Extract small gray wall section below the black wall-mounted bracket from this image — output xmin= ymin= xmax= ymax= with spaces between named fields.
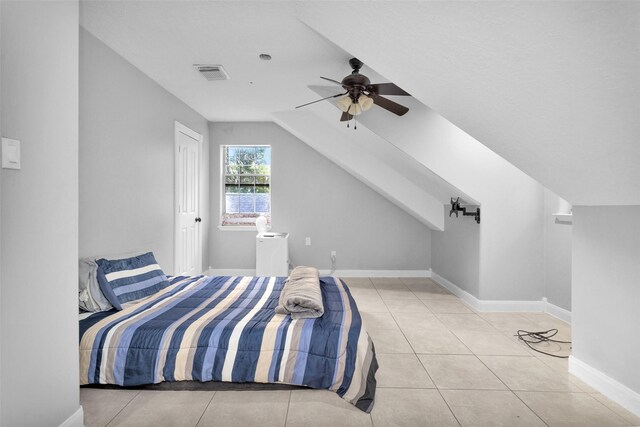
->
xmin=431 ymin=206 xmax=480 ymax=296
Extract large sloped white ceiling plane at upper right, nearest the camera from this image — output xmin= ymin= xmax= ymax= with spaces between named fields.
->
xmin=297 ymin=1 xmax=640 ymax=205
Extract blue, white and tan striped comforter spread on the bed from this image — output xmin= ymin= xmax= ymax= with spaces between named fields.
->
xmin=80 ymin=276 xmax=378 ymax=412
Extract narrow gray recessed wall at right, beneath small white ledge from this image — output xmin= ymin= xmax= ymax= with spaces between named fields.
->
xmin=544 ymin=188 xmax=572 ymax=311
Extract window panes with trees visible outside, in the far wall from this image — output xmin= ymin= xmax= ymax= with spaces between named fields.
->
xmin=222 ymin=145 xmax=271 ymax=226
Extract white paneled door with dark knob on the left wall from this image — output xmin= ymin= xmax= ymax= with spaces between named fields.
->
xmin=174 ymin=122 xmax=202 ymax=276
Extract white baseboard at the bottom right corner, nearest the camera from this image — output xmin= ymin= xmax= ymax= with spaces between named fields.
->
xmin=569 ymin=356 xmax=640 ymax=417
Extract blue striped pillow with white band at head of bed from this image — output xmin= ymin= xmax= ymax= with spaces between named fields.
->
xmin=96 ymin=252 xmax=169 ymax=310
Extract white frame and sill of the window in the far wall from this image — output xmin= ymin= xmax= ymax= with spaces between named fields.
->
xmin=218 ymin=144 xmax=273 ymax=230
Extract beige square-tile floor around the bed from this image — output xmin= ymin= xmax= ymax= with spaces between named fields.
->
xmin=80 ymin=278 xmax=640 ymax=427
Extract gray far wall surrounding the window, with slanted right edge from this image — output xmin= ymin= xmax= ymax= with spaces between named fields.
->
xmin=209 ymin=122 xmax=431 ymax=270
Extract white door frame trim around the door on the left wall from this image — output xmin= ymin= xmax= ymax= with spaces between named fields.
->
xmin=173 ymin=120 xmax=204 ymax=274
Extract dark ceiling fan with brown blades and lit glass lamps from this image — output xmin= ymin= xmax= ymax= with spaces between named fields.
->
xmin=296 ymin=58 xmax=410 ymax=122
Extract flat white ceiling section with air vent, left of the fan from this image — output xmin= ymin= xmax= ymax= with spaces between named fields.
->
xmin=81 ymin=1 xmax=351 ymax=121
